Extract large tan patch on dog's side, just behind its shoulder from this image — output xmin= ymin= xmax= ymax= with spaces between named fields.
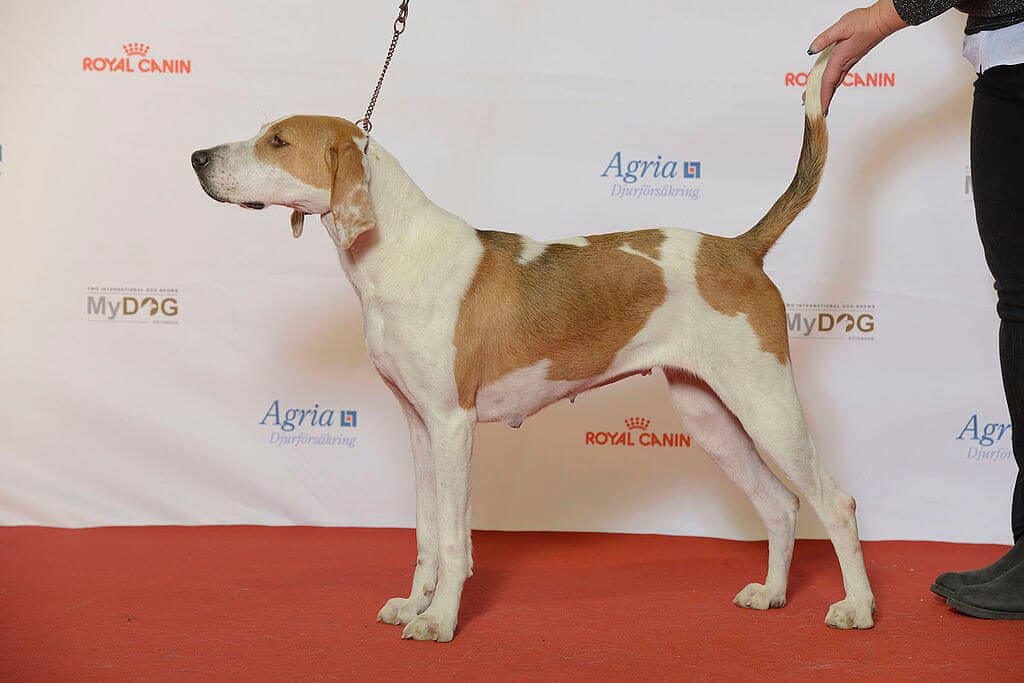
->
xmin=455 ymin=229 xmax=667 ymax=408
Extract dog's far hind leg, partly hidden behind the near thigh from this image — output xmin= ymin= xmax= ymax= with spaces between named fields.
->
xmin=665 ymin=369 xmax=800 ymax=609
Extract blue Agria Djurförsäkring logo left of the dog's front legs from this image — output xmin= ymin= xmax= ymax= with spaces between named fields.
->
xmin=259 ymin=398 xmax=359 ymax=449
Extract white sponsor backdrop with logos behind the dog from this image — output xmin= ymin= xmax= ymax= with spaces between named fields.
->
xmin=0 ymin=0 xmax=1015 ymax=542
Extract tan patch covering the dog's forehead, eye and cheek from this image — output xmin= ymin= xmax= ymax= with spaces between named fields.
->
xmin=253 ymin=116 xmax=364 ymax=189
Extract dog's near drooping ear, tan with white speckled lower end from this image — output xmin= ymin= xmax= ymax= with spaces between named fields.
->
xmin=328 ymin=139 xmax=377 ymax=247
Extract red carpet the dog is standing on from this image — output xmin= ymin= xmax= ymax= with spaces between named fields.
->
xmin=0 ymin=526 xmax=1024 ymax=681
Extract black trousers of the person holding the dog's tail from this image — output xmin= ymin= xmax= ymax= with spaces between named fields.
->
xmin=971 ymin=65 xmax=1024 ymax=542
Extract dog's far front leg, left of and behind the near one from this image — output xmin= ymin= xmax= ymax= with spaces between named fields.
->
xmin=377 ymin=397 xmax=437 ymax=624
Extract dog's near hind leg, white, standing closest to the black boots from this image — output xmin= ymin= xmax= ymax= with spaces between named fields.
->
xmin=710 ymin=362 xmax=874 ymax=629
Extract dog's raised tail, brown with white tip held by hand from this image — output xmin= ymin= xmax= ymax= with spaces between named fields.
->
xmin=736 ymin=47 xmax=831 ymax=258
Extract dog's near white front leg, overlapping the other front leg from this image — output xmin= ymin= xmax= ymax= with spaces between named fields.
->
xmin=401 ymin=410 xmax=476 ymax=642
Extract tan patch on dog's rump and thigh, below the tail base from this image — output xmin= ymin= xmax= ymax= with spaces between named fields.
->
xmin=696 ymin=234 xmax=790 ymax=366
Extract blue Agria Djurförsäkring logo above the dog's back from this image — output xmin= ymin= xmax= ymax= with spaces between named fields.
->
xmin=601 ymin=152 xmax=700 ymax=200
